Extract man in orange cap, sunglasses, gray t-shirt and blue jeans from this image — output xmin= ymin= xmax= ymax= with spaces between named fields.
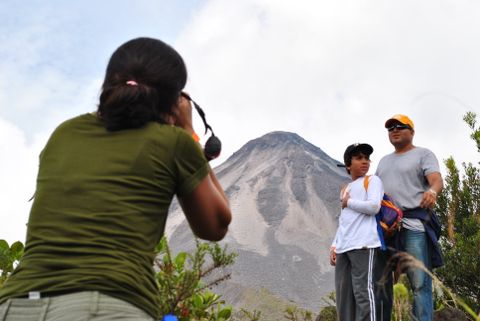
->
xmin=376 ymin=114 xmax=443 ymax=321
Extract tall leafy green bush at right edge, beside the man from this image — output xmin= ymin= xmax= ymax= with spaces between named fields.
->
xmin=436 ymin=112 xmax=480 ymax=311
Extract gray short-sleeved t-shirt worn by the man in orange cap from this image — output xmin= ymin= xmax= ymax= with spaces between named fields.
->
xmin=376 ymin=147 xmax=440 ymax=230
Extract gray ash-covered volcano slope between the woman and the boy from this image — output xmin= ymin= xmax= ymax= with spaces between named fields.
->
xmin=166 ymin=132 xmax=348 ymax=311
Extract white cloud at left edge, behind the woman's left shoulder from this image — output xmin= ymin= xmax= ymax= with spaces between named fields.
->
xmin=0 ymin=66 xmax=101 ymax=242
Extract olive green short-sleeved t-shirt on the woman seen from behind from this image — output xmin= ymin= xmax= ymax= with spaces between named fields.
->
xmin=0 ymin=114 xmax=209 ymax=318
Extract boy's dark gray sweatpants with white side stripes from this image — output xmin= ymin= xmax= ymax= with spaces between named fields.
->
xmin=335 ymin=248 xmax=390 ymax=321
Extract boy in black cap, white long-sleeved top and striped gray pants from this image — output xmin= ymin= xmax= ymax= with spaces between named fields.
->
xmin=330 ymin=144 xmax=390 ymax=321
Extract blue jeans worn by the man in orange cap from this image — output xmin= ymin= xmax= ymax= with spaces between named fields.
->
xmin=405 ymin=229 xmax=433 ymax=321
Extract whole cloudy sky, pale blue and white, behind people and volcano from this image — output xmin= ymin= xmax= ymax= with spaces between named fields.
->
xmin=0 ymin=0 xmax=480 ymax=242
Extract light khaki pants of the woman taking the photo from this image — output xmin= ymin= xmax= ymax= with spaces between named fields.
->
xmin=0 ymin=291 xmax=154 ymax=321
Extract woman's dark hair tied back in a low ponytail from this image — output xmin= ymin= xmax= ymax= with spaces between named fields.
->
xmin=98 ymin=38 xmax=187 ymax=131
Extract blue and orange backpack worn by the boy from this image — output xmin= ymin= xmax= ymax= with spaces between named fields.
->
xmin=363 ymin=176 xmax=403 ymax=251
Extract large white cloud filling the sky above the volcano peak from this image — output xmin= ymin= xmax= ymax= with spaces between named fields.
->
xmin=178 ymin=0 xmax=480 ymax=168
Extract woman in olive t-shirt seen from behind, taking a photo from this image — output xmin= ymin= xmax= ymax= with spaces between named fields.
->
xmin=0 ymin=38 xmax=231 ymax=321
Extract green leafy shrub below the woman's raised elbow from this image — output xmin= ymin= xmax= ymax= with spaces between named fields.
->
xmin=155 ymin=238 xmax=237 ymax=321
